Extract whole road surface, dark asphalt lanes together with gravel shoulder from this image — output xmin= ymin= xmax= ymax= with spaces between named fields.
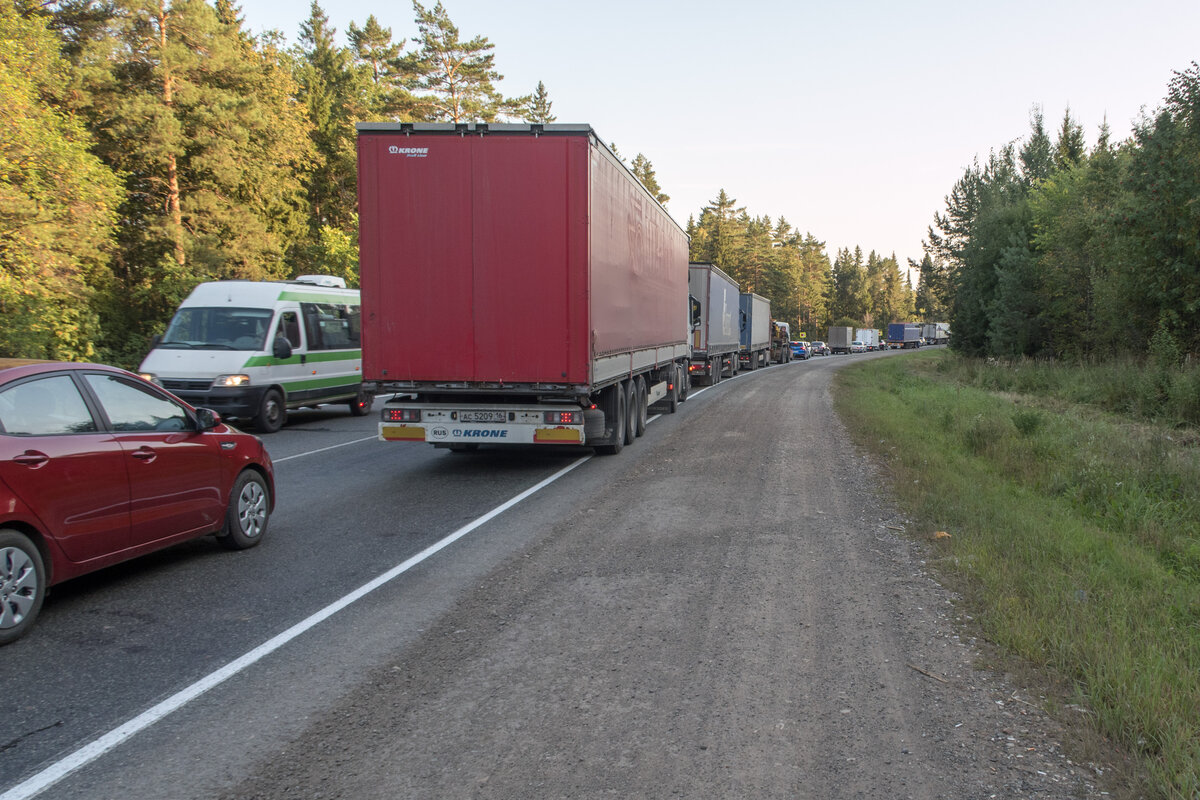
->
xmin=0 ymin=353 xmax=1099 ymax=800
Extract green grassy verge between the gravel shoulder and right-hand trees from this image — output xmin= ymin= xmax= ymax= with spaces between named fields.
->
xmin=835 ymin=350 xmax=1200 ymax=798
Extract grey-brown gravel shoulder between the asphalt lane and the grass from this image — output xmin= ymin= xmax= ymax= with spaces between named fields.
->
xmin=226 ymin=363 xmax=1123 ymax=799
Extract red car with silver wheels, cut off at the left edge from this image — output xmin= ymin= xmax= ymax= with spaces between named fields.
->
xmin=0 ymin=359 xmax=275 ymax=645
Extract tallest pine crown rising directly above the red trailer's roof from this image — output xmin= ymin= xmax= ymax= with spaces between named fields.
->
xmin=407 ymin=0 xmax=532 ymax=122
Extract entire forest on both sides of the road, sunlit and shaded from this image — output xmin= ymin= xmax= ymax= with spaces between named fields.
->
xmin=16 ymin=0 xmax=1200 ymax=366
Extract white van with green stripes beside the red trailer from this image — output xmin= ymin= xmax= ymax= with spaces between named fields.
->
xmin=139 ymin=275 xmax=372 ymax=433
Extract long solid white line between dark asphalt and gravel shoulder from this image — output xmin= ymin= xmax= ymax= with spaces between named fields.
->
xmin=0 ymin=455 xmax=593 ymax=800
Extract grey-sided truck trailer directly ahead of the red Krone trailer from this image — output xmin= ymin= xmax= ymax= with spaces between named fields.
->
xmin=688 ymin=263 xmax=742 ymax=385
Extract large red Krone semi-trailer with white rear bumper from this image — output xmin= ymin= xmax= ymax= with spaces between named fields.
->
xmin=358 ymin=122 xmax=691 ymax=453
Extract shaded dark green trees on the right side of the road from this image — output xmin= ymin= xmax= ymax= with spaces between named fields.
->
xmin=918 ymin=62 xmax=1200 ymax=363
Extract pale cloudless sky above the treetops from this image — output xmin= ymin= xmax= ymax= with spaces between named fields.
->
xmin=241 ymin=0 xmax=1200 ymax=272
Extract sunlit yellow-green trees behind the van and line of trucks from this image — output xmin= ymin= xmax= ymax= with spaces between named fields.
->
xmin=0 ymin=0 xmax=911 ymax=366
